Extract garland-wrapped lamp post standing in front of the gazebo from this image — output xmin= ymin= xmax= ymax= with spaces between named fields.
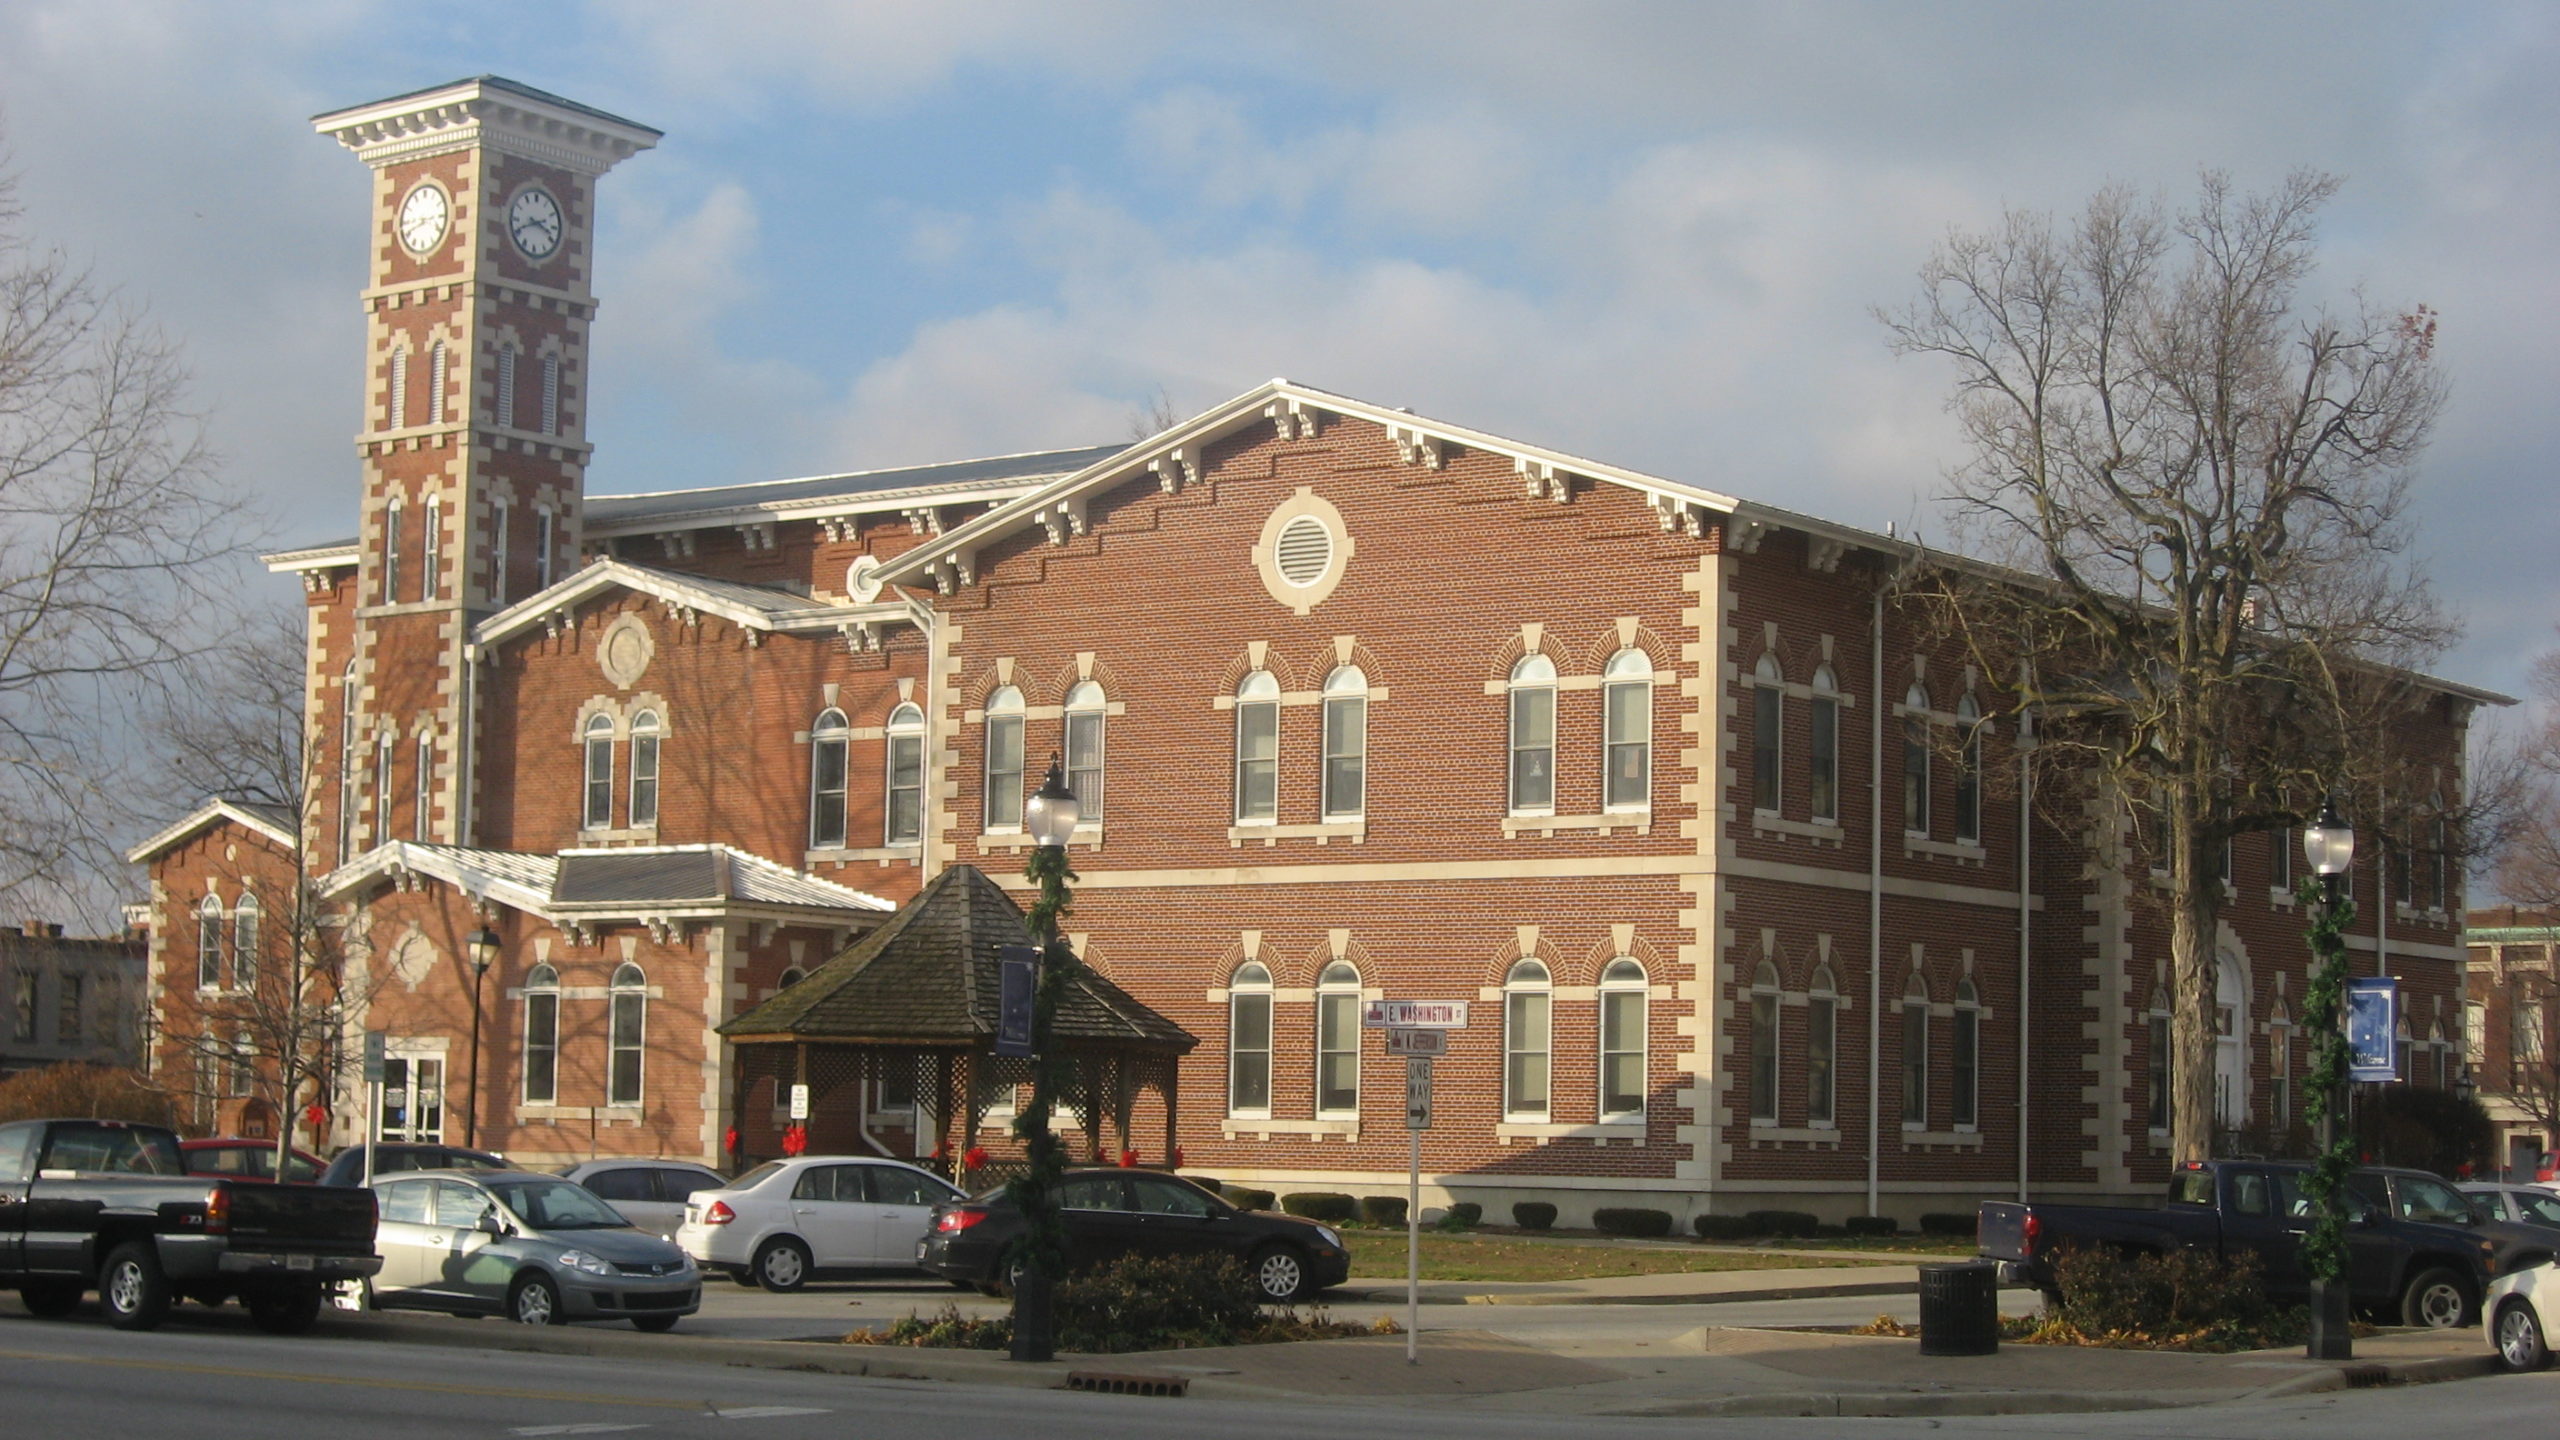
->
xmin=1006 ymin=756 xmax=1083 ymax=1361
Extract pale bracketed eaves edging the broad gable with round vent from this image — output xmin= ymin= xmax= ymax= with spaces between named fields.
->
xmin=881 ymin=379 xmax=1741 ymax=589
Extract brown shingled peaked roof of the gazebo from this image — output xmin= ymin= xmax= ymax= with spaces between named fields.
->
xmin=719 ymin=866 xmax=1198 ymax=1051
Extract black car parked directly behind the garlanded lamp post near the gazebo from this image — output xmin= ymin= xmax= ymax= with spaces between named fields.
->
xmin=916 ymin=1171 xmax=1352 ymax=1304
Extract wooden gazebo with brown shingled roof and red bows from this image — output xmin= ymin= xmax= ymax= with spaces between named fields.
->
xmin=719 ymin=866 xmax=1198 ymax=1179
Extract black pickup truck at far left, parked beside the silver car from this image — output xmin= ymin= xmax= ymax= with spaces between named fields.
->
xmin=0 ymin=1120 xmax=381 ymax=1335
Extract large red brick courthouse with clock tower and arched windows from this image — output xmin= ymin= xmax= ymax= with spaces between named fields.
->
xmin=124 ymin=79 xmax=2488 ymax=1222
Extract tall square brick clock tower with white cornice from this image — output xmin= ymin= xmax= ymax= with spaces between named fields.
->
xmin=312 ymin=74 xmax=658 ymax=840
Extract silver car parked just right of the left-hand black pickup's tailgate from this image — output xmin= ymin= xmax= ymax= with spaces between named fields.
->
xmin=371 ymin=1171 xmax=701 ymax=1330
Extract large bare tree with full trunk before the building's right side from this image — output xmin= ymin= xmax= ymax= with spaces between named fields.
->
xmin=1879 ymin=172 xmax=2452 ymax=1161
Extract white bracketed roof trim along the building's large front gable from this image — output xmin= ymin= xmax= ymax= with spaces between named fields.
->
xmin=881 ymin=379 xmax=1741 ymax=584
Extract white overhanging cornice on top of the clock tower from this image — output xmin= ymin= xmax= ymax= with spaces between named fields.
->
xmin=312 ymin=74 xmax=660 ymax=177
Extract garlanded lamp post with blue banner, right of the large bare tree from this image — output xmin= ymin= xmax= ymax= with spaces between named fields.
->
xmin=2301 ymin=802 xmax=2355 ymax=1361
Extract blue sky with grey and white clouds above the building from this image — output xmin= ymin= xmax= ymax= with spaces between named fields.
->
xmin=0 ymin=0 xmax=2560 ymax=712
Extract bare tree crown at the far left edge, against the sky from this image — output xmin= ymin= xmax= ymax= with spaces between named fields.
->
xmin=0 ymin=142 xmax=246 ymax=904
